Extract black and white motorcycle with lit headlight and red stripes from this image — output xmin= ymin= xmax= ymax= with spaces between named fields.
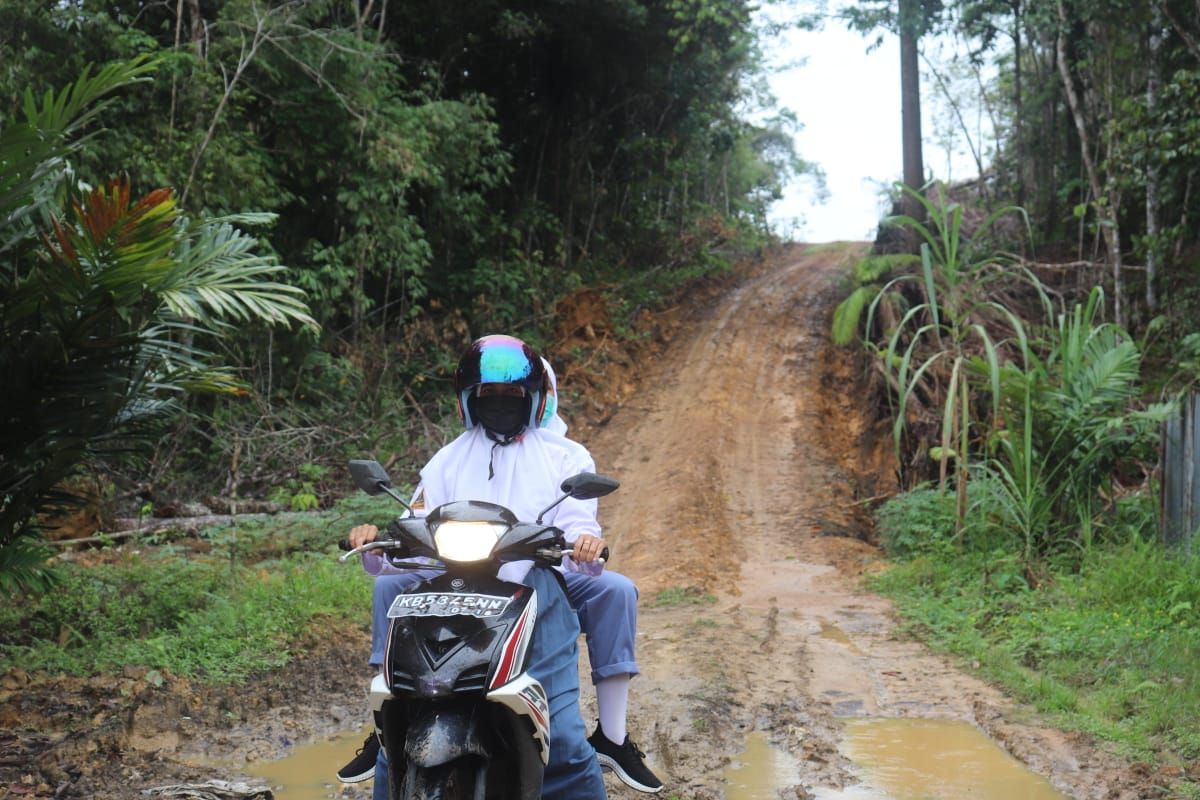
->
xmin=340 ymin=461 xmax=619 ymax=800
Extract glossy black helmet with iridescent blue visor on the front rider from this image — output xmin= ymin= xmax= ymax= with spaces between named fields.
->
xmin=454 ymin=335 xmax=546 ymax=429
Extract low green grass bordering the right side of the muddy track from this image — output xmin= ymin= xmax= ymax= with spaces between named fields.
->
xmin=874 ymin=499 xmax=1200 ymax=796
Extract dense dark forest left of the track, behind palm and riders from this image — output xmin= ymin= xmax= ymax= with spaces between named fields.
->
xmin=0 ymin=0 xmax=808 ymax=587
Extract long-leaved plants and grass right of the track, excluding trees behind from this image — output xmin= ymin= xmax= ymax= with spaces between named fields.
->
xmin=844 ymin=189 xmax=1200 ymax=796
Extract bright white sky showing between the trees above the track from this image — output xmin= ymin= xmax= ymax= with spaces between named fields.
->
xmin=762 ymin=0 xmax=993 ymax=242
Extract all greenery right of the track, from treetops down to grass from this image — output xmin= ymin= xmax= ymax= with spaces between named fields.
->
xmin=833 ymin=0 xmax=1200 ymax=782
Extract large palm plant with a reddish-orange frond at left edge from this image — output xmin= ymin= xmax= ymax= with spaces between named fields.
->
xmin=0 ymin=60 xmax=314 ymax=591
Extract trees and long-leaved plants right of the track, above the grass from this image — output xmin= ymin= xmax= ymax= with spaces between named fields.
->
xmin=834 ymin=0 xmax=1200 ymax=557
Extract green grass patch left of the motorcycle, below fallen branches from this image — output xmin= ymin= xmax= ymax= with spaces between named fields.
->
xmin=0 ymin=495 xmax=394 ymax=684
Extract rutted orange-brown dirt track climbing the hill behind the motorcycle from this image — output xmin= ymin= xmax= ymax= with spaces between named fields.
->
xmin=584 ymin=245 xmax=1138 ymax=800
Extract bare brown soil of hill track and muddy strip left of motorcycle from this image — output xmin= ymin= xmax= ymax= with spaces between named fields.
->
xmin=0 ymin=245 xmax=1158 ymax=800
